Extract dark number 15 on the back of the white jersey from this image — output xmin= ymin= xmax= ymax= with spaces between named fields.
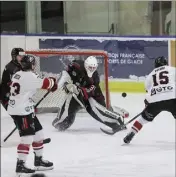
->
xmin=152 ymin=71 xmax=169 ymax=87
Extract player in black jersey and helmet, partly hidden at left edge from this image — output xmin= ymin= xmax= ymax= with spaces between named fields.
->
xmin=0 ymin=48 xmax=24 ymax=109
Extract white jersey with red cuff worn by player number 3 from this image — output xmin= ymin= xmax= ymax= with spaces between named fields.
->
xmin=8 ymin=71 xmax=53 ymax=115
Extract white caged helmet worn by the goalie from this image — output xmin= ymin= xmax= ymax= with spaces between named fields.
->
xmin=84 ymin=56 xmax=98 ymax=77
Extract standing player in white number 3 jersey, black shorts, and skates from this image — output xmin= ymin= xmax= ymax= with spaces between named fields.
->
xmin=7 ymin=55 xmax=57 ymax=176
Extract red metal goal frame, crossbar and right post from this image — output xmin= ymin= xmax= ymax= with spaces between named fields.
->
xmin=25 ymin=49 xmax=110 ymax=112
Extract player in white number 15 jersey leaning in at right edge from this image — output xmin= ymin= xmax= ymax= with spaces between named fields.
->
xmin=124 ymin=57 xmax=176 ymax=144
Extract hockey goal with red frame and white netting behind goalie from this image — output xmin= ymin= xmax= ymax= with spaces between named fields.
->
xmin=25 ymin=49 xmax=110 ymax=113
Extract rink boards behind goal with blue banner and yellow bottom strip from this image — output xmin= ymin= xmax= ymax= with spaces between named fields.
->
xmin=1 ymin=35 xmax=176 ymax=93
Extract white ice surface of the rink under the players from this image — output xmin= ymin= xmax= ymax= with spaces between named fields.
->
xmin=1 ymin=94 xmax=175 ymax=177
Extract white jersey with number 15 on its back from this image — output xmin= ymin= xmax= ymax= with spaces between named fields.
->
xmin=145 ymin=66 xmax=176 ymax=103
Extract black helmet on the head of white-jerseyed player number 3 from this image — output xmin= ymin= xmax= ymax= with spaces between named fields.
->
xmin=20 ymin=55 xmax=35 ymax=71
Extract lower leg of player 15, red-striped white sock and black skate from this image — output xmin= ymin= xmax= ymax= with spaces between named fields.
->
xmin=123 ymin=116 xmax=148 ymax=144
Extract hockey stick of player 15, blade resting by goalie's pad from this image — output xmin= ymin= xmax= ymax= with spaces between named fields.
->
xmin=100 ymin=111 xmax=143 ymax=135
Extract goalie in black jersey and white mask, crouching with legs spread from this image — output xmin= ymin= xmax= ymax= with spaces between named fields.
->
xmin=52 ymin=56 xmax=127 ymax=131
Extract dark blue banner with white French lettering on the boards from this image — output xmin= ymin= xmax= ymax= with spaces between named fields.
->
xmin=39 ymin=38 xmax=168 ymax=80
